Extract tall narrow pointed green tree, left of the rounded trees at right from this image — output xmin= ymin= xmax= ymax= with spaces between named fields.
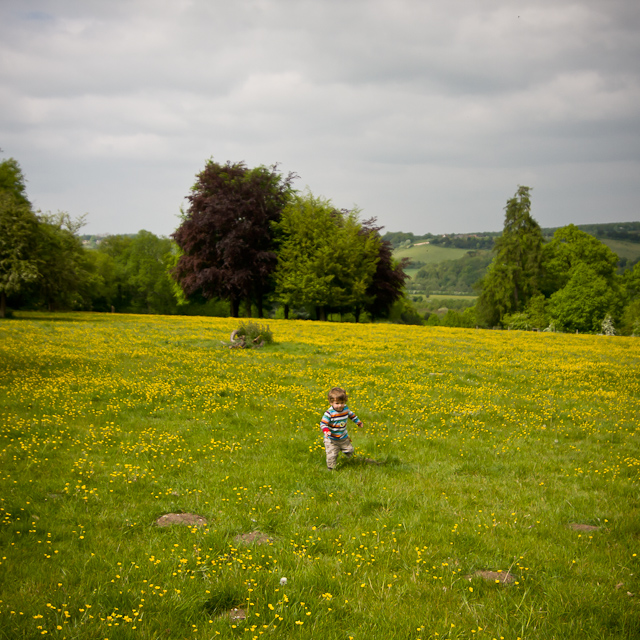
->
xmin=478 ymin=186 xmax=543 ymax=325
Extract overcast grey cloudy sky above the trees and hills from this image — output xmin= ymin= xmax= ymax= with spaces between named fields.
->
xmin=0 ymin=0 xmax=640 ymax=235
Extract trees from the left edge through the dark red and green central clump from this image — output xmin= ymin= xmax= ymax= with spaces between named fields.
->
xmin=0 ymin=159 xmax=408 ymax=321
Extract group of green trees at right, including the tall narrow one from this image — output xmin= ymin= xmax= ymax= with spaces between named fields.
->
xmin=474 ymin=186 xmax=640 ymax=335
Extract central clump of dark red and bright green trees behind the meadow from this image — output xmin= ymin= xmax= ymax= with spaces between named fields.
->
xmin=173 ymin=160 xmax=406 ymax=322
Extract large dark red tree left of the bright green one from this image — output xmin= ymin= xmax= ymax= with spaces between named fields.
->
xmin=172 ymin=160 xmax=296 ymax=318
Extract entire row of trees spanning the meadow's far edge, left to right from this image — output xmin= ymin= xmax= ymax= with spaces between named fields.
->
xmin=0 ymin=158 xmax=640 ymax=335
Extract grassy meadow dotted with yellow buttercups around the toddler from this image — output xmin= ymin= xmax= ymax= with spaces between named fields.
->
xmin=0 ymin=314 xmax=640 ymax=640
